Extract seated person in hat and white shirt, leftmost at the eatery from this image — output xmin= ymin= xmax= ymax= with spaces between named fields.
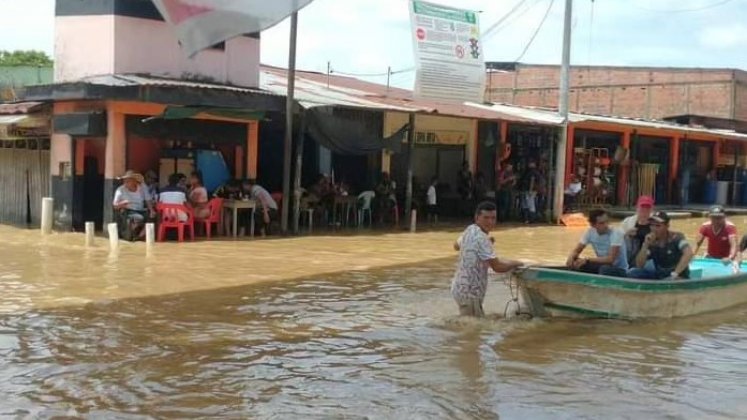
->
xmin=112 ymin=171 xmax=156 ymax=240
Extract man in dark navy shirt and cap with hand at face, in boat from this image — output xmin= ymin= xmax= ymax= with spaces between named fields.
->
xmin=628 ymin=211 xmax=693 ymax=280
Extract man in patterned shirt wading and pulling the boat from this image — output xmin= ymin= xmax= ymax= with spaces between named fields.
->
xmin=451 ymin=202 xmax=524 ymax=318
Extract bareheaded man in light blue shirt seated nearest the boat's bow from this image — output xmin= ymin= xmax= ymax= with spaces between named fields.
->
xmin=566 ymin=209 xmax=628 ymax=277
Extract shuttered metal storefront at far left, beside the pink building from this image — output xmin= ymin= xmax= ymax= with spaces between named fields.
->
xmin=0 ymin=107 xmax=50 ymax=226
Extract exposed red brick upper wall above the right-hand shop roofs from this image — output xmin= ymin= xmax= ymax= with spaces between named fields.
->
xmin=487 ymin=64 xmax=747 ymax=119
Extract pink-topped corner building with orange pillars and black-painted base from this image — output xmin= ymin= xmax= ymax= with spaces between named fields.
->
xmin=25 ymin=0 xmax=285 ymax=229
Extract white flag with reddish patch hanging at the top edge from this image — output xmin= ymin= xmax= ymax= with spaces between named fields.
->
xmin=153 ymin=0 xmax=313 ymax=57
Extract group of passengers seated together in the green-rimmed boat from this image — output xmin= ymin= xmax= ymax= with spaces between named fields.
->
xmin=566 ymin=196 xmax=747 ymax=280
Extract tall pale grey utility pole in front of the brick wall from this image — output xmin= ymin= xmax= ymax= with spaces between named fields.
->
xmin=553 ymin=0 xmax=573 ymax=222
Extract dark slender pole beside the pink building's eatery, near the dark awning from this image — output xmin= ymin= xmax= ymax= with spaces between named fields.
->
xmin=280 ymin=12 xmax=298 ymax=234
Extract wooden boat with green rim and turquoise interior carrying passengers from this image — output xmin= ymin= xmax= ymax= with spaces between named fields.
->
xmin=514 ymin=259 xmax=747 ymax=319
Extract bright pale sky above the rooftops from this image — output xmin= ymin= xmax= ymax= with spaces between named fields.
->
xmin=0 ymin=0 xmax=747 ymax=88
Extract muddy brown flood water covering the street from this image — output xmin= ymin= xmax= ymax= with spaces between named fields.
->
xmin=0 ymin=218 xmax=747 ymax=419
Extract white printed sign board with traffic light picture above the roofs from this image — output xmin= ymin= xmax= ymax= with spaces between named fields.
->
xmin=410 ymin=0 xmax=485 ymax=103
